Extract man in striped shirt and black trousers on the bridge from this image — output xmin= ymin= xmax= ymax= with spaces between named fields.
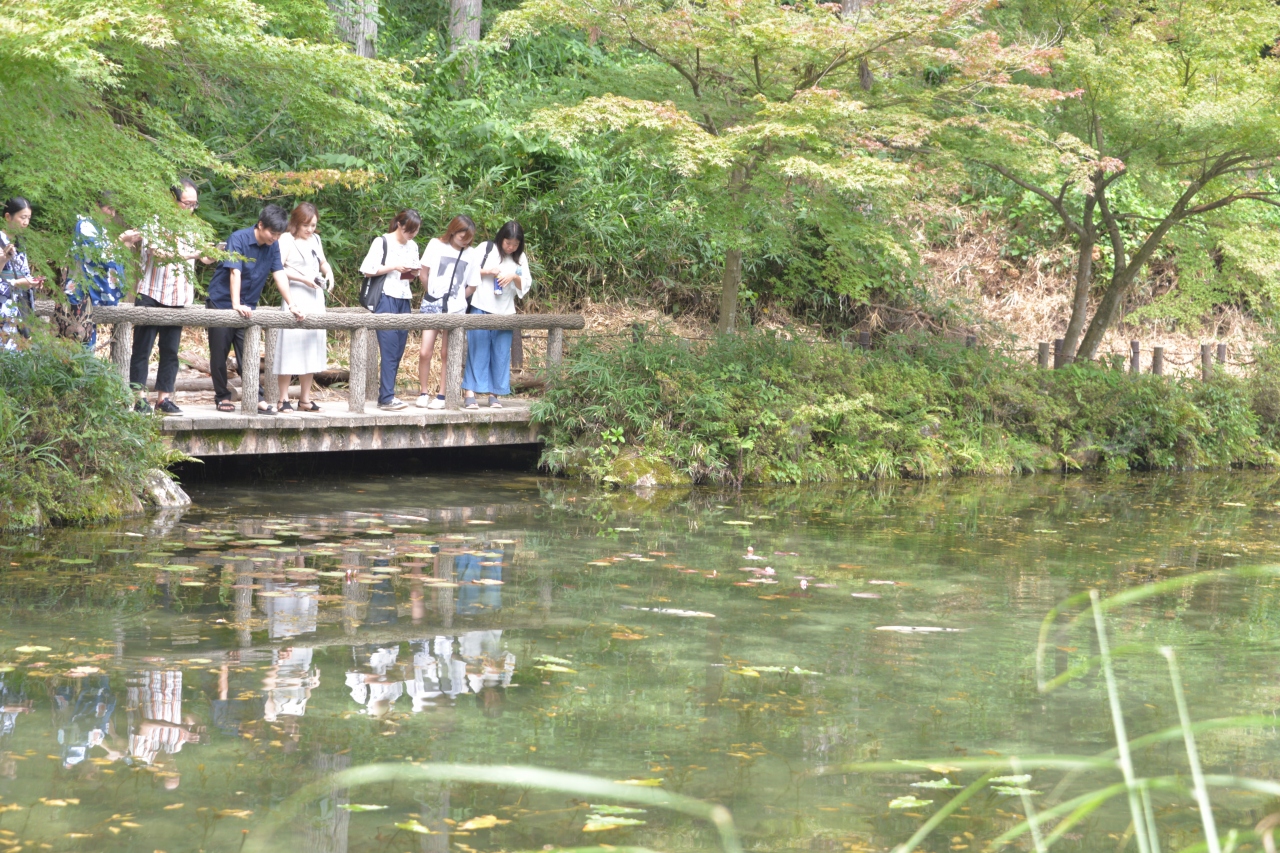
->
xmin=129 ymin=179 xmax=200 ymax=415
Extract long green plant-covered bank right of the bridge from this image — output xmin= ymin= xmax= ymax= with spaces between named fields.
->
xmin=534 ymin=333 xmax=1280 ymax=485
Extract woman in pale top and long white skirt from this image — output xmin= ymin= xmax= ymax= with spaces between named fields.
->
xmin=273 ymin=201 xmax=333 ymax=411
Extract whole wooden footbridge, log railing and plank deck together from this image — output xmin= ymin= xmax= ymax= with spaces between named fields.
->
xmin=64 ymin=304 xmax=584 ymax=456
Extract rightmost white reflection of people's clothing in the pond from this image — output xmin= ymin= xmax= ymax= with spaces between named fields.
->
xmin=404 ymin=630 xmax=516 ymax=711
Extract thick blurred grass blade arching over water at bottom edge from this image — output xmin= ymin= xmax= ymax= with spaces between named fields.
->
xmin=243 ymin=763 xmax=742 ymax=853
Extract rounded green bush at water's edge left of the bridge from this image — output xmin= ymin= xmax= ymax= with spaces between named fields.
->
xmin=0 ymin=330 xmax=174 ymax=528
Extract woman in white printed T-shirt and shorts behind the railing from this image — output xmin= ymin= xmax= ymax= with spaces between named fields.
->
xmin=417 ymin=216 xmax=480 ymax=409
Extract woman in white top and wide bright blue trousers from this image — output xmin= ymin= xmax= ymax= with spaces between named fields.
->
xmin=462 ymin=219 xmax=534 ymax=409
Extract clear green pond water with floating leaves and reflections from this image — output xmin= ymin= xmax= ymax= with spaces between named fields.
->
xmin=0 ymin=474 xmax=1280 ymax=853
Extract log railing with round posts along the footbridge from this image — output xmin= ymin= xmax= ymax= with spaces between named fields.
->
xmin=36 ymin=302 xmax=585 ymax=414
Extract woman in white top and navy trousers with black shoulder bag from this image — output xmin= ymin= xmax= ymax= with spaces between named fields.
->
xmin=360 ymin=209 xmax=422 ymax=411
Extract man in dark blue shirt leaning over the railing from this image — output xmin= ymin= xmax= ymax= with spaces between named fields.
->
xmin=205 ymin=205 xmax=300 ymax=415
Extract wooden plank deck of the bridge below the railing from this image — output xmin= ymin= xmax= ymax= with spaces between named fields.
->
xmin=160 ymin=397 xmax=539 ymax=456
